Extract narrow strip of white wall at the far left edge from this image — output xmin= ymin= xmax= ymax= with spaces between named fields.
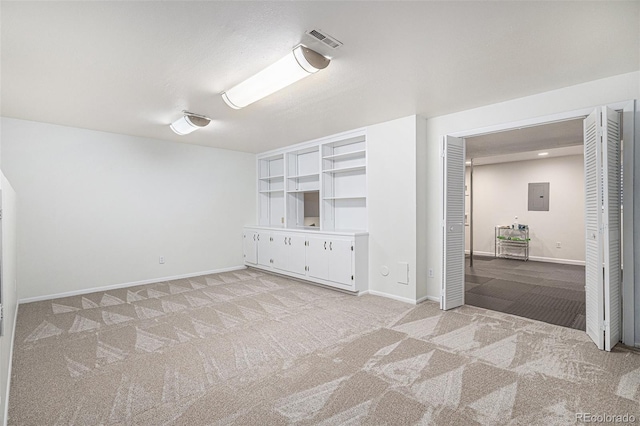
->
xmin=0 ymin=174 xmax=18 ymax=424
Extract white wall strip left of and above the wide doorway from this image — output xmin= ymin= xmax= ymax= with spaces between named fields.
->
xmin=417 ymin=72 xmax=640 ymax=304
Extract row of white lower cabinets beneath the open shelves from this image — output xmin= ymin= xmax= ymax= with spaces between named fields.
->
xmin=245 ymin=227 xmax=369 ymax=292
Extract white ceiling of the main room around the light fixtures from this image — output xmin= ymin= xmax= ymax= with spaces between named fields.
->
xmin=0 ymin=1 xmax=640 ymax=152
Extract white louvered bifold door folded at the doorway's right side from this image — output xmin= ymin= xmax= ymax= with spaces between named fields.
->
xmin=584 ymin=107 xmax=620 ymax=351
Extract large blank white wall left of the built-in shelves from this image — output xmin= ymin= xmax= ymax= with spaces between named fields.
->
xmin=2 ymin=118 xmax=256 ymax=299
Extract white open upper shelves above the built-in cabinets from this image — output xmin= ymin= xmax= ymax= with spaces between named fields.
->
xmin=258 ymin=130 xmax=368 ymax=231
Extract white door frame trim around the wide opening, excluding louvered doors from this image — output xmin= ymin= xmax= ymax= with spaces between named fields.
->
xmin=440 ymin=100 xmax=640 ymax=346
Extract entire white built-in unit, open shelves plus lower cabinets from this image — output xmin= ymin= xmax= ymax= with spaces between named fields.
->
xmin=248 ymin=130 xmax=369 ymax=293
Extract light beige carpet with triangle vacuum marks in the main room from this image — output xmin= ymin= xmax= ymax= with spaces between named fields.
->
xmin=9 ymin=269 xmax=640 ymax=425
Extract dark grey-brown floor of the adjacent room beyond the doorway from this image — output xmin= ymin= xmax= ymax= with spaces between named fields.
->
xmin=465 ymin=256 xmax=586 ymax=331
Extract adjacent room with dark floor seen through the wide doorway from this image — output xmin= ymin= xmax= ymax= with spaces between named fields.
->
xmin=465 ymin=120 xmax=586 ymax=331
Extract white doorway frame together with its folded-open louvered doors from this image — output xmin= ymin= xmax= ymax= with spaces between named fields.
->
xmin=441 ymin=101 xmax=636 ymax=350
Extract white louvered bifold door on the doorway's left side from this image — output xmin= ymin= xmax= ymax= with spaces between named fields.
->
xmin=440 ymin=136 xmax=465 ymax=310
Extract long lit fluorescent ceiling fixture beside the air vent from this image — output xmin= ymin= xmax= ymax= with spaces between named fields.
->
xmin=222 ymin=45 xmax=331 ymax=109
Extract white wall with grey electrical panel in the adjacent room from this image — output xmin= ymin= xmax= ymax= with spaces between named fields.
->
xmin=465 ymin=155 xmax=585 ymax=264
